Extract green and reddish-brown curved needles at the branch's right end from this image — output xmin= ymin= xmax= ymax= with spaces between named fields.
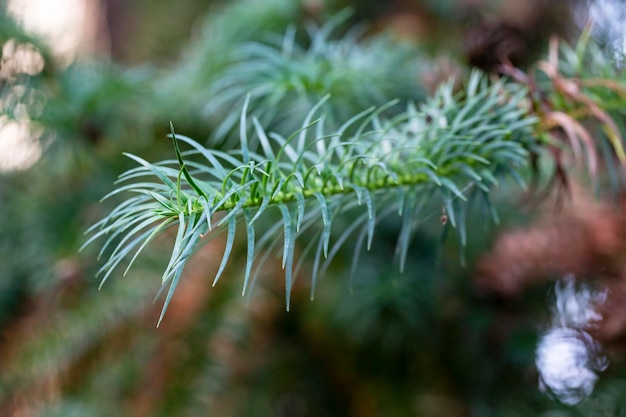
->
xmin=500 ymin=31 xmax=626 ymax=195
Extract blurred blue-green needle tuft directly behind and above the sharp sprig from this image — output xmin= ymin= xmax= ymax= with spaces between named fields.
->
xmin=204 ymin=10 xmax=424 ymax=147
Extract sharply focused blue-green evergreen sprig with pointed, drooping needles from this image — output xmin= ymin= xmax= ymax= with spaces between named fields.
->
xmin=85 ymin=73 xmax=536 ymax=323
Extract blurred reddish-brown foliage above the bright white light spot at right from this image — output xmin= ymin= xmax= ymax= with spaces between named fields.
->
xmin=475 ymin=184 xmax=626 ymax=342
